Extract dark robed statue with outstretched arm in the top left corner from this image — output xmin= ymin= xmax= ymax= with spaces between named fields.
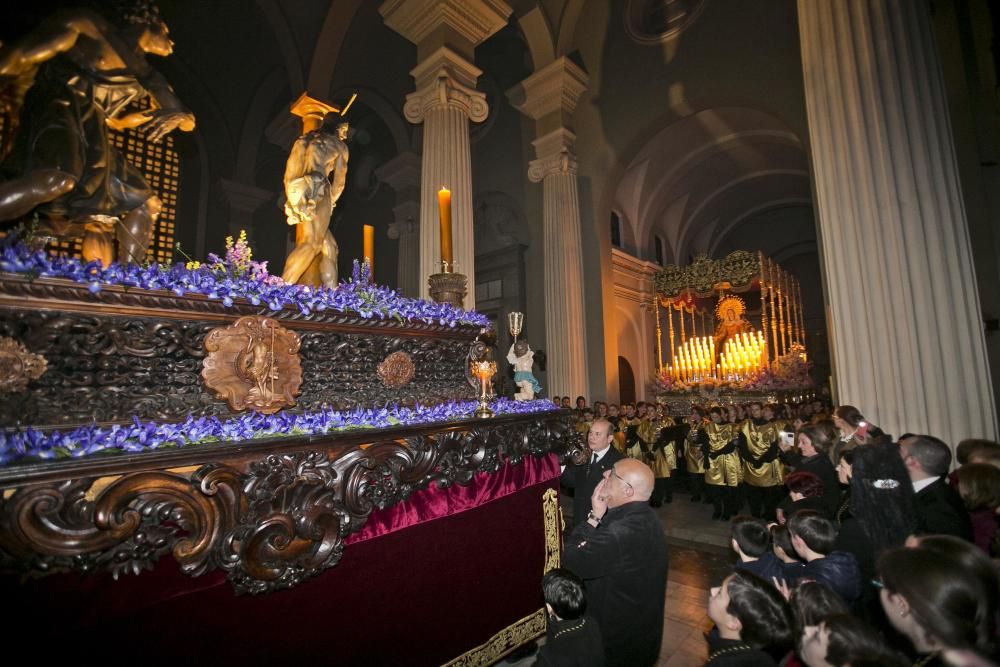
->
xmin=0 ymin=0 xmax=195 ymax=265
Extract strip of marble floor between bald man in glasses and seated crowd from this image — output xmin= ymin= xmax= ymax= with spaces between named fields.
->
xmin=498 ymin=492 xmax=735 ymax=667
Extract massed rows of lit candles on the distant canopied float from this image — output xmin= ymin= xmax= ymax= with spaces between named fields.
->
xmin=667 ymin=331 xmax=767 ymax=382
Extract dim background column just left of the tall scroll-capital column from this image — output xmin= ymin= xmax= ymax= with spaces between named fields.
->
xmin=375 ymin=152 xmax=421 ymax=298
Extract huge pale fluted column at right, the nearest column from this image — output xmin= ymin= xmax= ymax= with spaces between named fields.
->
xmin=798 ymin=0 xmax=997 ymax=445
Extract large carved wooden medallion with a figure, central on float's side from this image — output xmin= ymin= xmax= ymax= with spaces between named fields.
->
xmin=201 ymin=315 xmax=302 ymax=415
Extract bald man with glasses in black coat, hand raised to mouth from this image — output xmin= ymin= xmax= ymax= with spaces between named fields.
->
xmin=563 ymin=459 xmax=667 ymax=667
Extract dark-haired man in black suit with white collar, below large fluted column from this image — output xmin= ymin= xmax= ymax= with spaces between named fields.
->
xmin=899 ymin=435 xmax=972 ymax=542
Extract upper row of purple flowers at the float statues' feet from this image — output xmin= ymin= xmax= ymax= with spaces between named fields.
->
xmin=0 ymin=243 xmax=492 ymax=327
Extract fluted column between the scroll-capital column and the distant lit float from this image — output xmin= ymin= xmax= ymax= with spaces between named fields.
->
xmin=507 ymin=57 xmax=591 ymax=396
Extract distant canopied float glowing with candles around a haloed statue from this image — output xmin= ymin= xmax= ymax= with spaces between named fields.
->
xmin=652 ymin=250 xmax=812 ymax=412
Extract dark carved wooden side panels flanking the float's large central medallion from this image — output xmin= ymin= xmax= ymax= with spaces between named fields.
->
xmin=0 ymin=308 xmax=474 ymax=426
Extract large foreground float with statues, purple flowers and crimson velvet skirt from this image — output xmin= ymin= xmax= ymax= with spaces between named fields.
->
xmin=0 ymin=0 xmax=582 ymax=665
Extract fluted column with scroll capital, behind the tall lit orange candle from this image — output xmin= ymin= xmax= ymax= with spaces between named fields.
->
xmin=379 ymin=0 xmax=512 ymax=309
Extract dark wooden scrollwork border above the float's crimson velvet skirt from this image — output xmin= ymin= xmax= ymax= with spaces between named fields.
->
xmin=0 ymin=413 xmax=582 ymax=594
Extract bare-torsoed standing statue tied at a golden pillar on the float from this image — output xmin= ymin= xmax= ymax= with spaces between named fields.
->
xmin=281 ymin=116 xmax=350 ymax=287
